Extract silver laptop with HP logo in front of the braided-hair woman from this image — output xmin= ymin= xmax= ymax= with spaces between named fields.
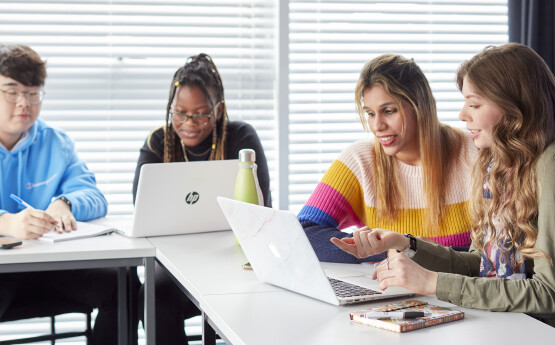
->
xmin=115 ymin=159 xmax=239 ymax=237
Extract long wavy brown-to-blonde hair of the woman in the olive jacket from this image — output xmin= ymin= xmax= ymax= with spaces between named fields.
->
xmin=457 ymin=43 xmax=555 ymax=261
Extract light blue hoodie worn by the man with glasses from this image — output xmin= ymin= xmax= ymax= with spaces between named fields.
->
xmin=0 ymin=119 xmax=108 ymax=221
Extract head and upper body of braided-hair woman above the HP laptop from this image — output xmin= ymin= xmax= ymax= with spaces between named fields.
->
xmin=133 ymin=54 xmax=271 ymax=206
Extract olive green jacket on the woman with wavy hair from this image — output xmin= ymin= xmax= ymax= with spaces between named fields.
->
xmin=413 ymin=143 xmax=555 ymax=326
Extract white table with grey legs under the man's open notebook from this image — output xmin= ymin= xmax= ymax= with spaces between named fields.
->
xmin=0 ymin=234 xmax=156 ymax=344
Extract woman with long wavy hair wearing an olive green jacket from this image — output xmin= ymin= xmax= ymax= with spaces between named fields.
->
xmin=332 ymin=43 xmax=555 ymax=326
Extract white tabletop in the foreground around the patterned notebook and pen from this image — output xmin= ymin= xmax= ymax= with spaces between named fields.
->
xmin=202 ymin=291 xmax=555 ymax=345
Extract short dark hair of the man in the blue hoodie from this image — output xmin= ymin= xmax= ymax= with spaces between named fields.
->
xmin=0 ymin=44 xmax=46 ymax=86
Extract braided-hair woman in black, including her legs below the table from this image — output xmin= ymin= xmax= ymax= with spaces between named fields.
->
xmin=133 ymin=54 xmax=271 ymax=345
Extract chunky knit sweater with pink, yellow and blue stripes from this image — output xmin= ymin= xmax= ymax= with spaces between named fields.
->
xmin=297 ymin=139 xmax=476 ymax=263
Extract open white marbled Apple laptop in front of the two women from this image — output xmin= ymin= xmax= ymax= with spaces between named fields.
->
xmin=218 ymin=197 xmax=414 ymax=305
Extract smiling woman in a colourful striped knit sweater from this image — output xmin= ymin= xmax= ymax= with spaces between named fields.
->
xmin=298 ymin=54 xmax=476 ymax=263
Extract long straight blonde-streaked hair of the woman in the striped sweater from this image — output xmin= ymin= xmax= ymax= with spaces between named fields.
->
xmin=355 ymin=54 xmax=465 ymax=235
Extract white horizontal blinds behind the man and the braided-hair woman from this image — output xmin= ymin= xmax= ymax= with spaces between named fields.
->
xmin=0 ymin=0 xmax=277 ymax=214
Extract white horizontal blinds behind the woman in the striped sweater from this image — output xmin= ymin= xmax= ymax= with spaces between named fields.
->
xmin=289 ymin=0 xmax=508 ymax=211
